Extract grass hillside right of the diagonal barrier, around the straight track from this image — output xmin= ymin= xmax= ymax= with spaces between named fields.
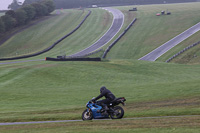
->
xmin=108 ymin=3 xmax=200 ymax=61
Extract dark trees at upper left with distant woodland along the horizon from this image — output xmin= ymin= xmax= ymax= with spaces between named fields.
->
xmin=0 ymin=0 xmax=197 ymax=35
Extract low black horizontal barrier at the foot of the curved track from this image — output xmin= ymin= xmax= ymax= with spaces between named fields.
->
xmin=45 ymin=57 xmax=101 ymax=61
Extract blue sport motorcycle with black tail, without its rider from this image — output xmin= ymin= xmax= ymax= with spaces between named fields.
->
xmin=82 ymin=97 xmax=126 ymax=120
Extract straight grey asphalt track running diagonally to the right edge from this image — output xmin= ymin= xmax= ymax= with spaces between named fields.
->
xmin=138 ymin=22 xmax=200 ymax=61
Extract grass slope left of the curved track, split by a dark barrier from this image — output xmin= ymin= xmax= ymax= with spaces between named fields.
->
xmin=0 ymin=9 xmax=112 ymax=58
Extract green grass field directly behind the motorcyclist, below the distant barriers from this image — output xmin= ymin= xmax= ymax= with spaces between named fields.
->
xmin=0 ymin=60 xmax=200 ymax=122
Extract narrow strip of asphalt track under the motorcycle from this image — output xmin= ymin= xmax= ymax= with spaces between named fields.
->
xmin=0 ymin=115 xmax=200 ymax=126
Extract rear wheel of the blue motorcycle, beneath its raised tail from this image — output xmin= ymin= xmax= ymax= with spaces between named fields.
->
xmin=110 ymin=106 xmax=124 ymax=119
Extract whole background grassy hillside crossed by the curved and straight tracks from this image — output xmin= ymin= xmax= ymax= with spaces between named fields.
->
xmin=0 ymin=3 xmax=200 ymax=63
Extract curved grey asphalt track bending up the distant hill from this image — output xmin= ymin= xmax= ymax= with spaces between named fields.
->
xmin=69 ymin=7 xmax=124 ymax=57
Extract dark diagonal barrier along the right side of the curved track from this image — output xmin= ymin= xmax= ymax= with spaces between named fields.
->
xmin=102 ymin=18 xmax=137 ymax=58
